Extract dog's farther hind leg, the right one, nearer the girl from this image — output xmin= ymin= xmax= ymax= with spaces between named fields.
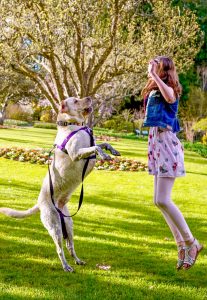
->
xmin=63 ymin=205 xmax=85 ymax=265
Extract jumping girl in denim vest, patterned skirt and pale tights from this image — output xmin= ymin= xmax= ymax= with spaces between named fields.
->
xmin=142 ymin=56 xmax=203 ymax=270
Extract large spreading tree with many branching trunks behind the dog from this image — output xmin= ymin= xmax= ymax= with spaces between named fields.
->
xmin=0 ymin=0 xmax=204 ymax=122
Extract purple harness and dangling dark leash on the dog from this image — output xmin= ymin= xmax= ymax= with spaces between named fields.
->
xmin=48 ymin=127 xmax=96 ymax=239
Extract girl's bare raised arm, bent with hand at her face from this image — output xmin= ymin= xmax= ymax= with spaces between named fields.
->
xmin=148 ymin=60 xmax=176 ymax=103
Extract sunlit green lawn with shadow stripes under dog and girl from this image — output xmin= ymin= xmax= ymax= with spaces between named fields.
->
xmin=0 ymin=128 xmax=207 ymax=300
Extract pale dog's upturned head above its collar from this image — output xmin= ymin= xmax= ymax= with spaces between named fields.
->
xmin=60 ymin=97 xmax=93 ymax=123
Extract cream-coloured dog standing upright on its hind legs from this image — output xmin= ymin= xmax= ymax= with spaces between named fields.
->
xmin=0 ymin=97 xmax=120 ymax=272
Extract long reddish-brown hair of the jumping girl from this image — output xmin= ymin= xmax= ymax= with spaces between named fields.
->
xmin=142 ymin=56 xmax=182 ymax=98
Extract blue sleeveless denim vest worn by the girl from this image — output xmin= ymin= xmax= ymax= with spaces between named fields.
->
xmin=143 ymin=90 xmax=180 ymax=132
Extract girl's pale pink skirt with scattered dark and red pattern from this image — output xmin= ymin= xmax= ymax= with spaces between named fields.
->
xmin=148 ymin=127 xmax=185 ymax=177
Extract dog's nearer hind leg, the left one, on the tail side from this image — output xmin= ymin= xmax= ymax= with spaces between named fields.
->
xmin=40 ymin=207 xmax=73 ymax=272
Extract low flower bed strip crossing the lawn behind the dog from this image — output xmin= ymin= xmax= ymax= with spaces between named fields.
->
xmin=0 ymin=147 xmax=147 ymax=171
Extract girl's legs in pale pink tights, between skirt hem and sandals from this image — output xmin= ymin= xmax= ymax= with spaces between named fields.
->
xmin=156 ymin=177 xmax=194 ymax=244
